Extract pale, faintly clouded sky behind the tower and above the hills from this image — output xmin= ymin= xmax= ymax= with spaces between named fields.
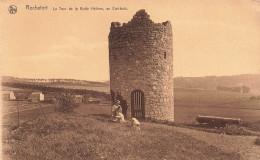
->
xmin=0 ymin=0 xmax=260 ymax=81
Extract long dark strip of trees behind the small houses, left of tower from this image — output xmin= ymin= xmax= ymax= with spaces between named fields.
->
xmin=2 ymin=83 xmax=110 ymax=100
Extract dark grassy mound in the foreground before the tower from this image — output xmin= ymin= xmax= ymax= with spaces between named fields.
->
xmin=3 ymin=114 xmax=240 ymax=160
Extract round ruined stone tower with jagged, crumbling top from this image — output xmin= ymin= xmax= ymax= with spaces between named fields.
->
xmin=109 ymin=10 xmax=174 ymax=121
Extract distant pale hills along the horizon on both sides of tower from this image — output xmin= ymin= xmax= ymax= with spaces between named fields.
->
xmin=2 ymin=74 xmax=260 ymax=94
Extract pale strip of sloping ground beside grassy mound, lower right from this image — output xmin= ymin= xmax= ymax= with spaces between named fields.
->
xmin=175 ymin=127 xmax=260 ymax=160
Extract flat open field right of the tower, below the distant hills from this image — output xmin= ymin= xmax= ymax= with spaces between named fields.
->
xmin=174 ymin=88 xmax=260 ymax=123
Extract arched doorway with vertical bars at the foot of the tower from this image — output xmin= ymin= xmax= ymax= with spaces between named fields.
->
xmin=131 ymin=90 xmax=145 ymax=119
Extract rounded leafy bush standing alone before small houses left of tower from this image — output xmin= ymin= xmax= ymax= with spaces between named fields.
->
xmin=55 ymin=92 xmax=79 ymax=113
